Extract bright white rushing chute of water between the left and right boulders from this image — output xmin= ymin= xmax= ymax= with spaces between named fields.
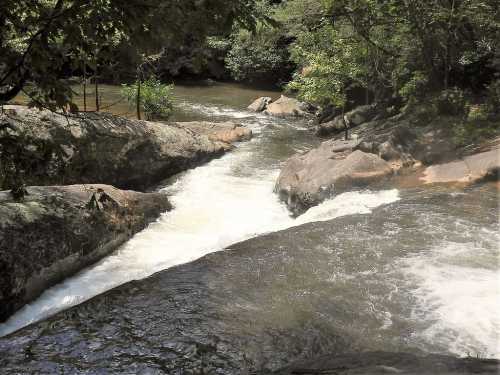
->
xmin=0 ymin=135 xmax=398 ymax=335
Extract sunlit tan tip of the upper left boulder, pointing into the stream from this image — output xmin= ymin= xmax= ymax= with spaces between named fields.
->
xmin=177 ymin=121 xmax=252 ymax=144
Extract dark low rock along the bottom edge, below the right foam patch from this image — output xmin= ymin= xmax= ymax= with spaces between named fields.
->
xmin=273 ymin=351 xmax=500 ymax=375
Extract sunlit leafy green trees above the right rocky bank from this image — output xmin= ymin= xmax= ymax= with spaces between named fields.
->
xmin=226 ymin=0 xmax=500 ymax=109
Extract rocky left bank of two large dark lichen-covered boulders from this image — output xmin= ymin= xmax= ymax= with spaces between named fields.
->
xmin=0 ymin=106 xmax=252 ymax=321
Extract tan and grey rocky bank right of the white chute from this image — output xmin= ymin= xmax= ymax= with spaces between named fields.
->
xmin=262 ymin=98 xmax=500 ymax=215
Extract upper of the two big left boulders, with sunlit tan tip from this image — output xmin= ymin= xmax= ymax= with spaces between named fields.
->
xmin=0 ymin=106 xmax=248 ymax=190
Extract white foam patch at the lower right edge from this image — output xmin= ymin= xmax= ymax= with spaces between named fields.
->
xmin=405 ymin=241 xmax=500 ymax=358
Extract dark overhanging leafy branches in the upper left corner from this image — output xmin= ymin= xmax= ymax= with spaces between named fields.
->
xmin=0 ymin=0 xmax=262 ymax=111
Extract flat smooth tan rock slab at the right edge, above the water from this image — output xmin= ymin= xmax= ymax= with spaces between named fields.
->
xmin=422 ymin=149 xmax=500 ymax=184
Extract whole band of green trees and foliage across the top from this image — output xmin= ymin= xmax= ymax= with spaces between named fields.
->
xmin=0 ymin=0 xmax=500 ymax=112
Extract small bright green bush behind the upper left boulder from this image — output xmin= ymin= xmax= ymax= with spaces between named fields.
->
xmin=122 ymin=78 xmax=174 ymax=120
